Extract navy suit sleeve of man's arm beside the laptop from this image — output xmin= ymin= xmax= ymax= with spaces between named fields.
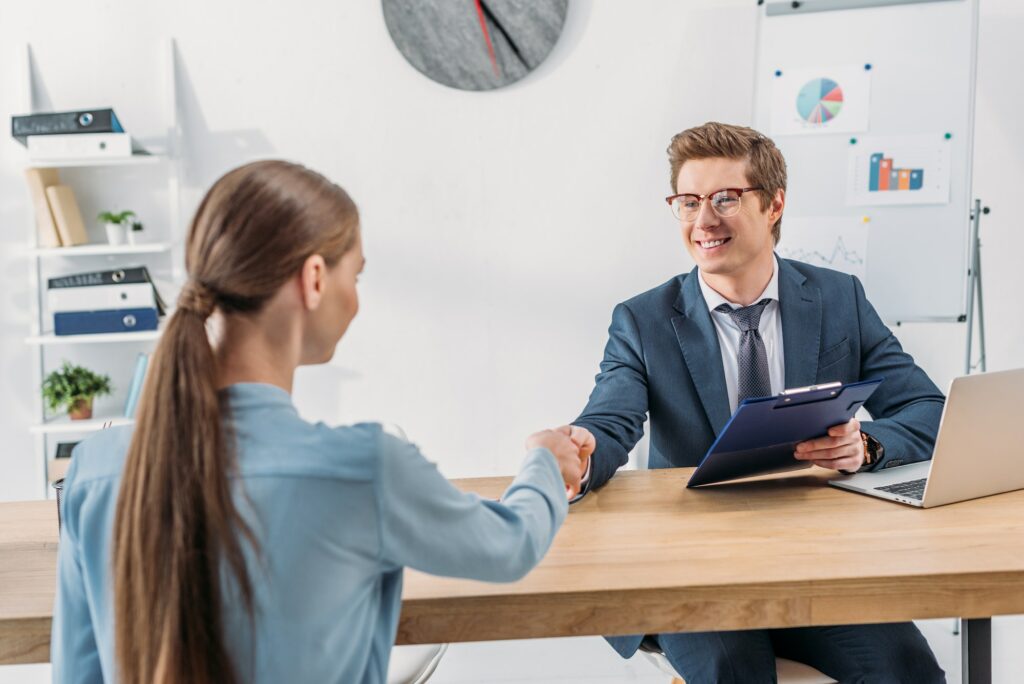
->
xmin=853 ymin=277 xmax=945 ymax=470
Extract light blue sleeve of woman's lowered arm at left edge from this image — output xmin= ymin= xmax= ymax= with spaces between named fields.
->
xmin=50 ymin=459 xmax=103 ymax=684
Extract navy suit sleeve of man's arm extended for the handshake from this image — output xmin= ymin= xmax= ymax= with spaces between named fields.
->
xmin=573 ymin=304 xmax=647 ymax=493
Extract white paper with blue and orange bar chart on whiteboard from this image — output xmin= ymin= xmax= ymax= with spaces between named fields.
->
xmin=847 ymin=133 xmax=950 ymax=206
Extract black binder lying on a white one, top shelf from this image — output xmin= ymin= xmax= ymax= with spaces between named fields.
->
xmin=10 ymin=109 xmax=147 ymax=162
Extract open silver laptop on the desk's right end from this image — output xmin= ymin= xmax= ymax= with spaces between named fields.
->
xmin=828 ymin=369 xmax=1024 ymax=508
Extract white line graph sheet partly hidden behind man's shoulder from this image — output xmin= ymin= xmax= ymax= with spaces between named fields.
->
xmin=776 ymin=216 xmax=869 ymax=283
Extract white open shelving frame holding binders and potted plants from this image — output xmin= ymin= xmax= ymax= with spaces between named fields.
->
xmin=23 ymin=40 xmax=183 ymax=498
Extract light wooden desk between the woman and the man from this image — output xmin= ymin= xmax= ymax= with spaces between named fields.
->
xmin=0 ymin=469 xmax=1024 ymax=681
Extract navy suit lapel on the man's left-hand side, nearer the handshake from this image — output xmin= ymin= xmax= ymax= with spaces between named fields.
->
xmin=672 ymin=268 xmax=729 ymax=435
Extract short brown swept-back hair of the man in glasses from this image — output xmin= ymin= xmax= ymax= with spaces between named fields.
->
xmin=668 ymin=121 xmax=785 ymax=245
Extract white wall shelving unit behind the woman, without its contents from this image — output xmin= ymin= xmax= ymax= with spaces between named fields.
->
xmin=22 ymin=37 xmax=184 ymax=497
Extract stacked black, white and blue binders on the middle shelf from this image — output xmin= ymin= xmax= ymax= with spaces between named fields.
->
xmin=46 ymin=266 xmax=166 ymax=335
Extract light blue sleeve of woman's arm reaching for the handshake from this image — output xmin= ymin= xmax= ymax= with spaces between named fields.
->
xmin=378 ymin=434 xmax=568 ymax=582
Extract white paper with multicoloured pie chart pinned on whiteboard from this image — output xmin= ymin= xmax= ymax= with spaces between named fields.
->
xmin=769 ymin=65 xmax=871 ymax=135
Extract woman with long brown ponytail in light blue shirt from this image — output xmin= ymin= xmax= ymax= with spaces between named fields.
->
xmin=52 ymin=161 xmax=592 ymax=684
